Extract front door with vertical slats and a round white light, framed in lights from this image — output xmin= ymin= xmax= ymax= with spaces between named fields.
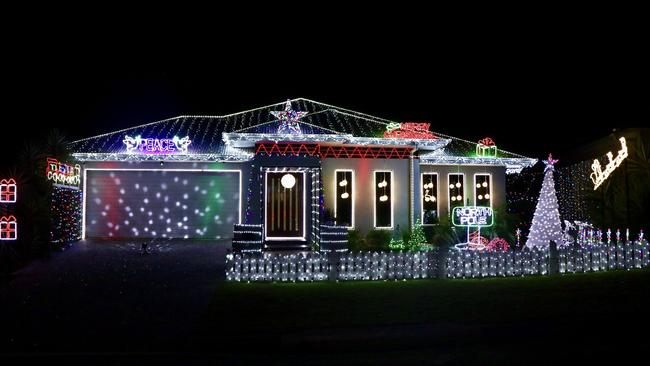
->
xmin=264 ymin=171 xmax=306 ymax=241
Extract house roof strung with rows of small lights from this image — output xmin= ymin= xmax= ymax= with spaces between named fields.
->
xmin=70 ymin=98 xmax=536 ymax=172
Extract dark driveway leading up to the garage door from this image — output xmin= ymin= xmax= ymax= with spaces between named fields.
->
xmin=0 ymin=240 xmax=230 ymax=354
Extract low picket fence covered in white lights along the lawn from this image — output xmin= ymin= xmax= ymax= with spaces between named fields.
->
xmin=226 ymin=240 xmax=650 ymax=282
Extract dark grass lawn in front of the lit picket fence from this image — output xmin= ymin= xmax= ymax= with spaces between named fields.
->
xmin=198 ymin=269 xmax=650 ymax=362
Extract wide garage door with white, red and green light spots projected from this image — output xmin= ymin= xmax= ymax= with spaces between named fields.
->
xmin=85 ymin=170 xmax=241 ymax=239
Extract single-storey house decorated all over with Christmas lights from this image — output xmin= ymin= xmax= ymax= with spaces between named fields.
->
xmin=71 ymin=98 xmax=536 ymax=249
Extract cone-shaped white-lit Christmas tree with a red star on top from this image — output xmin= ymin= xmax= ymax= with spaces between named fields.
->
xmin=526 ymin=154 xmax=563 ymax=248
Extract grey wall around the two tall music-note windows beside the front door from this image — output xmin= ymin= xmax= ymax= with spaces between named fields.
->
xmin=322 ymin=158 xmax=411 ymax=234
